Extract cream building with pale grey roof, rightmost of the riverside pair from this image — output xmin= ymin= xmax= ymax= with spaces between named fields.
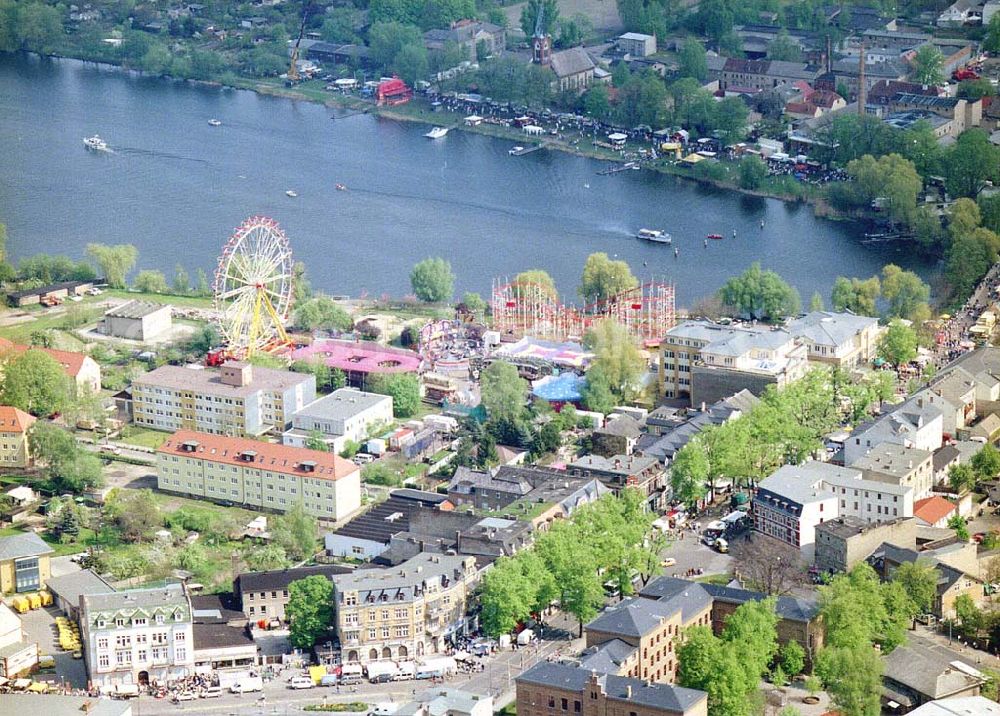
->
xmin=786 ymin=311 xmax=882 ymax=369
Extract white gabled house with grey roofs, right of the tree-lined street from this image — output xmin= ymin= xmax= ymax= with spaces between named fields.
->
xmin=844 ymin=396 xmax=944 ymax=465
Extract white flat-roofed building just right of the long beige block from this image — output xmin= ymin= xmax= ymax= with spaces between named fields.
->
xmin=282 ymin=388 xmax=394 ymax=453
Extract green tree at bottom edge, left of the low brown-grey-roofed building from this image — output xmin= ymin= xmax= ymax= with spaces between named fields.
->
xmin=816 ymin=645 xmax=882 ymax=716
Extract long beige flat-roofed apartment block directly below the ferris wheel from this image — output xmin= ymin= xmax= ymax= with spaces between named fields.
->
xmin=132 ymin=362 xmax=316 ymax=437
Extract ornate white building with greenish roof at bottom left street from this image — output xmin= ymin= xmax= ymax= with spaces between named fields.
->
xmin=80 ymin=584 xmax=194 ymax=689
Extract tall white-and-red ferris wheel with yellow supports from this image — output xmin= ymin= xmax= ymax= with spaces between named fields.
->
xmin=213 ymin=216 xmax=293 ymax=359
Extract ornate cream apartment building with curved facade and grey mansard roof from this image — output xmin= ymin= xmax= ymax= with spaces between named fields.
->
xmin=333 ymin=553 xmax=479 ymax=664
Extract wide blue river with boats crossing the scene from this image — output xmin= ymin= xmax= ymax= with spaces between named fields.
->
xmin=0 ymin=55 xmax=931 ymax=305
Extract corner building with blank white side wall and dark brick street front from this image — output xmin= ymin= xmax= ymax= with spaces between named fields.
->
xmin=753 ymin=465 xmax=837 ymax=549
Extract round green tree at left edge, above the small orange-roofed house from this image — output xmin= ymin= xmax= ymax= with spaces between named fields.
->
xmin=0 ymin=349 xmax=70 ymax=417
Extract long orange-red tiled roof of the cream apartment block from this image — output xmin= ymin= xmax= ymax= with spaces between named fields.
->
xmin=156 ymin=430 xmax=359 ymax=480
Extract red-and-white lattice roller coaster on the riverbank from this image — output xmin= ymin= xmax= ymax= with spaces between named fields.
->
xmin=490 ymin=279 xmax=676 ymax=341
